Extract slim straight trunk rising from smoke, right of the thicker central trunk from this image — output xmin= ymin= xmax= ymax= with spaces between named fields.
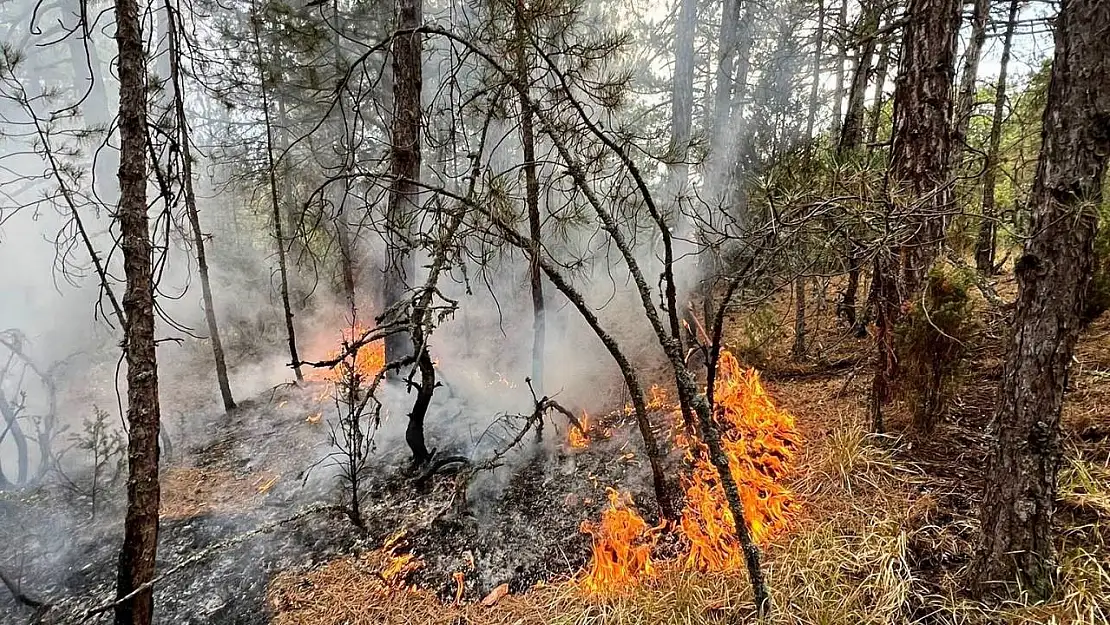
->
xmin=513 ymin=0 xmax=546 ymax=395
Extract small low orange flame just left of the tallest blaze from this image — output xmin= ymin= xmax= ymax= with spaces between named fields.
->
xmin=579 ymin=488 xmax=663 ymax=593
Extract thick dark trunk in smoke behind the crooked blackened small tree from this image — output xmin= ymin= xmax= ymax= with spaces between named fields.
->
xmin=382 ymin=0 xmax=424 ymax=368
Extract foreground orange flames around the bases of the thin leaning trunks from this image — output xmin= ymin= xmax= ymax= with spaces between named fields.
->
xmin=581 ymin=351 xmax=800 ymax=593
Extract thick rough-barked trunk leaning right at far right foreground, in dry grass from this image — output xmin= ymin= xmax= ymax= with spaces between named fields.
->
xmin=973 ymin=0 xmax=1110 ymax=598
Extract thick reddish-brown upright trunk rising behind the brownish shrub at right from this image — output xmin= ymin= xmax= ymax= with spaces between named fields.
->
xmin=890 ymin=0 xmax=961 ymax=296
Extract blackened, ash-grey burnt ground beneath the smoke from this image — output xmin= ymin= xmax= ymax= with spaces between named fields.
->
xmin=0 ymin=368 xmax=664 ymax=625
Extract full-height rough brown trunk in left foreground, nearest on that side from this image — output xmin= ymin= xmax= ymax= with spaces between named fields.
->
xmin=115 ymin=0 xmax=160 ymax=625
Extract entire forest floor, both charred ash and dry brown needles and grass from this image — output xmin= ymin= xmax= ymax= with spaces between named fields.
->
xmin=0 ymin=274 xmax=1110 ymax=625
